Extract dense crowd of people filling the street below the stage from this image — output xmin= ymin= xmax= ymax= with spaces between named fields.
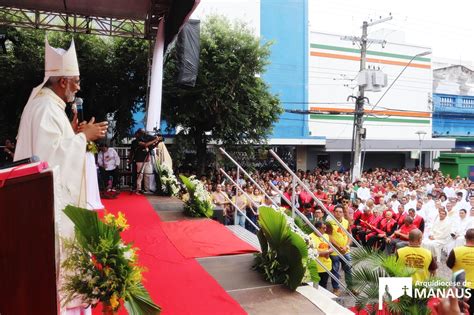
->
xmin=206 ymin=168 xmax=474 ymax=312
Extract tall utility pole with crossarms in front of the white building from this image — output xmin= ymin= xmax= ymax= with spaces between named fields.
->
xmin=342 ymin=15 xmax=392 ymax=182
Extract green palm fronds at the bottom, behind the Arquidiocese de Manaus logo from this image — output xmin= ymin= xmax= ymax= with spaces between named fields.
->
xmin=351 ymin=247 xmax=447 ymax=315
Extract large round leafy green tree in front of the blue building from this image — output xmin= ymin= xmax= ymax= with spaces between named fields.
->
xmin=163 ymin=16 xmax=282 ymax=173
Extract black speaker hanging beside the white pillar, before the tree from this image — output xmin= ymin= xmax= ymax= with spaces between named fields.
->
xmin=176 ymin=20 xmax=201 ymax=87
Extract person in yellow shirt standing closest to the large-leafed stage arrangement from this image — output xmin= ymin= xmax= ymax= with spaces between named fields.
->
xmin=310 ymin=221 xmax=333 ymax=289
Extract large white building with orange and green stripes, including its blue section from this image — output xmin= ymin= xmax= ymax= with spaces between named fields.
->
xmin=189 ymin=0 xmax=454 ymax=169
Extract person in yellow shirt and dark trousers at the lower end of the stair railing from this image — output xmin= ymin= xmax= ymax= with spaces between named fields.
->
xmin=328 ymin=205 xmax=352 ymax=295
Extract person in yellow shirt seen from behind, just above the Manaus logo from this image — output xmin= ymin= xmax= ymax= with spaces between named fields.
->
xmin=397 ymin=229 xmax=438 ymax=282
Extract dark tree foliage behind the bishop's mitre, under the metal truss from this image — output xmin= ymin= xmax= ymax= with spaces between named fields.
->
xmin=0 ymin=27 xmax=149 ymax=143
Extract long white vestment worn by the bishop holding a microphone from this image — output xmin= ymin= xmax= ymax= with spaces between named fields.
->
xmin=15 ymin=88 xmax=87 ymax=313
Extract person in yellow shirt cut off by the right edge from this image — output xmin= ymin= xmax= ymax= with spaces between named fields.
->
xmin=446 ymin=229 xmax=474 ymax=315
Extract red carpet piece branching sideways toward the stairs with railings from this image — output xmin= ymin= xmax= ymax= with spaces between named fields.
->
xmin=161 ymin=219 xmax=257 ymax=258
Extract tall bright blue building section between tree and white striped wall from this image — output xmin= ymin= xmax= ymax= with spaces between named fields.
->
xmin=260 ymin=0 xmax=322 ymax=139
